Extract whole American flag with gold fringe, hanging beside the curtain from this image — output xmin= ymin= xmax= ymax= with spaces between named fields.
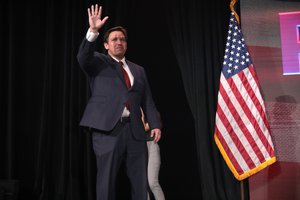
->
xmin=214 ymin=13 xmax=276 ymax=180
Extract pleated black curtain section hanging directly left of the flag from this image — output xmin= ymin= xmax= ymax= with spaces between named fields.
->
xmin=168 ymin=0 xmax=249 ymax=200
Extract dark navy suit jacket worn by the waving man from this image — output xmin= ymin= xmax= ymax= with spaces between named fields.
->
xmin=77 ymin=38 xmax=161 ymax=140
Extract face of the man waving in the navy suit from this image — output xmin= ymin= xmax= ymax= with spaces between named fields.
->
xmin=104 ymin=31 xmax=127 ymax=60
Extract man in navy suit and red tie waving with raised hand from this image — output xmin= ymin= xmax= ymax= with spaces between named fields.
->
xmin=77 ymin=5 xmax=161 ymax=200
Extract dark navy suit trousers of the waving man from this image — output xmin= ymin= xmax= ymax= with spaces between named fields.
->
xmin=92 ymin=121 xmax=148 ymax=200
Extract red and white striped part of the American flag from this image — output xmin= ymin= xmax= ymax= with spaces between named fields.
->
xmin=215 ymin=65 xmax=274 ymax=175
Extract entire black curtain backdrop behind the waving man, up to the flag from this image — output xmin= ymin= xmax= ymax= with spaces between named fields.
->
xmin=0 ymin=0 xmax=247 ymax=200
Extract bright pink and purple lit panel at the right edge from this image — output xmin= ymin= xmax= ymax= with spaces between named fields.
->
xmin=279 ymin=11 xmax=300 ymax=75
